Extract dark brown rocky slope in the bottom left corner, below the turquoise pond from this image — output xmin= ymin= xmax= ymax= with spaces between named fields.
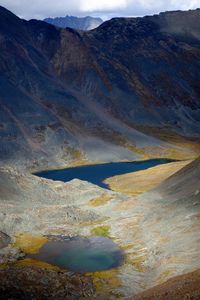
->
xmin=0 ymin=266 xmax=94 ymax=300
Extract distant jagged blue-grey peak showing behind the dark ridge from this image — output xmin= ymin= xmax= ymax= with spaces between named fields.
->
xmin=44 ymin=16 xmax=103 ymax=30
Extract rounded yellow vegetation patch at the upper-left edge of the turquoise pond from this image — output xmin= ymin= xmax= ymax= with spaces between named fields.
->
xmin=14 ymin=233 xmax=48 ymax=254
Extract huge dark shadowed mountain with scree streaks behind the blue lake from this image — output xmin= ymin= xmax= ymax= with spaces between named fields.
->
xmin=0 ymin=7 xmax=200 ymax=169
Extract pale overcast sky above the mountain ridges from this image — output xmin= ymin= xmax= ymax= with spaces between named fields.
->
xmin=0 ymin=0 xmax=200 ymax=19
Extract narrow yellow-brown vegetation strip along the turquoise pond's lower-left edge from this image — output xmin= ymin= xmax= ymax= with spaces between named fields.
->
xmin=14 ymin=258 xmax=61 ymax=272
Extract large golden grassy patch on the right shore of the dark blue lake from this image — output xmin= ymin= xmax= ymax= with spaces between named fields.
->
xmin=105 ymin=161 xmax=191 ymax=196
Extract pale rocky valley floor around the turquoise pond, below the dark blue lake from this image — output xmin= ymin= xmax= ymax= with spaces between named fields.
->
xmin=0 ymin=159 xmax=200 ymax=299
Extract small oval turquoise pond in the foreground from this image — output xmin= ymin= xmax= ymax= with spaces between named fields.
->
xmin=29 ymin=236 xmax=124 ymax=273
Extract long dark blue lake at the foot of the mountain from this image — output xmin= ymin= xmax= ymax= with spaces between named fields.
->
xmin=35 ymin=159 xmax=172 ymax=188
